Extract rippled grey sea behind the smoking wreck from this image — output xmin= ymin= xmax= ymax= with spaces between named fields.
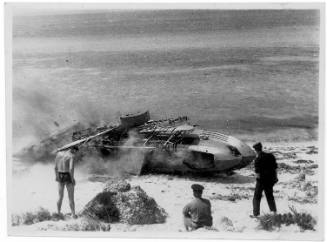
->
xmin=12 ymin=10 xmax=320 ymax=147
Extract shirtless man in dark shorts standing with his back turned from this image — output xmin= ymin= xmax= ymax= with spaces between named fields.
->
xmin=55 ymin=146 xmax=78 ymax=218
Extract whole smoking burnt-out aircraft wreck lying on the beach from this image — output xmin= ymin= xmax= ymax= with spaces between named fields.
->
xmin=18 ymin=111 xmax=255 ymax=174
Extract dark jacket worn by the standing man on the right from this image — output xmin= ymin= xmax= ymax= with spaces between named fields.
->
xmin=254 ymin=152 xmax=277 ymax=184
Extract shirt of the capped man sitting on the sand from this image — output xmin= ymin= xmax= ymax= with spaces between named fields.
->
xmin=183 ymin=198 xmax=212 ymax=226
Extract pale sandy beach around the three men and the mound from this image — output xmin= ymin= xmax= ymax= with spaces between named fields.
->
xmin=11 ymin=142 xmax=319 ymax=235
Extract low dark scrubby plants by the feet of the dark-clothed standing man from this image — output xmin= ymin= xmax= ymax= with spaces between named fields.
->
xmin=259 ymin=207 xmax=317 ymax=232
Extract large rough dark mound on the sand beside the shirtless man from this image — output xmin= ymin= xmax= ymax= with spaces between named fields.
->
xmin=80 ymin=180 xmax=167 ymax=224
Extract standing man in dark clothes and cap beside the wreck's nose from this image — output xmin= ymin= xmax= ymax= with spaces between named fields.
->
xmin=250 ymin=143 xmax=278 ymax=217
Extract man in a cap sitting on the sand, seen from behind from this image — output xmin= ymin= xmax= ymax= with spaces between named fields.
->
xmin=183 ymin=184 xmax=212 ymax=231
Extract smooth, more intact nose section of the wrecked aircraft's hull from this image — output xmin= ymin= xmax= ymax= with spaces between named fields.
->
xmin=138 ymin=130 xmax=255 ymax=174
